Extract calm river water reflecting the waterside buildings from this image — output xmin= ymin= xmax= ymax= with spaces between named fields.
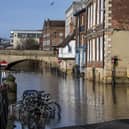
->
xmin=8 ymin=61 xmax=129 ymax=129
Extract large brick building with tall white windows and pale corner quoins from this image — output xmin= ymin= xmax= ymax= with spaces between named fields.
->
xmin=73 ymin=0 xmax=129 ymax=83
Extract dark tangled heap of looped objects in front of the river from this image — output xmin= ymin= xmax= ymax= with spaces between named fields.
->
xmin=16 ymin=90 xmax=61 ymax=129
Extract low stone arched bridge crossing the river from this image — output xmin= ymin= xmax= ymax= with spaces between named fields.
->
xmin=0 ymin=50 xmax=59 ymax=69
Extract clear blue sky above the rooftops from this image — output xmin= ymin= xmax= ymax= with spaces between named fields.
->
xmin=0 ymin=0 xmax=73 ymax=38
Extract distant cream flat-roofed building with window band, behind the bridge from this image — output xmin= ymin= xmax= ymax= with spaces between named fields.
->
xmin=10 ymin=30 xmax=42 ymax=49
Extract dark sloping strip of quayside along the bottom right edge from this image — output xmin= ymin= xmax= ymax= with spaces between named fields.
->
xmin=56 ymin=119 xmax=129 ymax=129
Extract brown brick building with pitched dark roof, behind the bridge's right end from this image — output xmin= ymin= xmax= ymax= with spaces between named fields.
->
xmin=42 ymin=19 xmax=65 ymax=50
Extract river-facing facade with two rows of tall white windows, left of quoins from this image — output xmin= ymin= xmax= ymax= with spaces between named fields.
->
xmin=85 ymin=0 xmax=105 ymax=81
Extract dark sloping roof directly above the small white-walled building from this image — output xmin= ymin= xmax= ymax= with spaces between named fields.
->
xmin=56 ymin=31 xmax=75 ymax=47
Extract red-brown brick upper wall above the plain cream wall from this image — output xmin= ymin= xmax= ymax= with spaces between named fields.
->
xmin=112 ymin=0 xmax=129 ymax=30
